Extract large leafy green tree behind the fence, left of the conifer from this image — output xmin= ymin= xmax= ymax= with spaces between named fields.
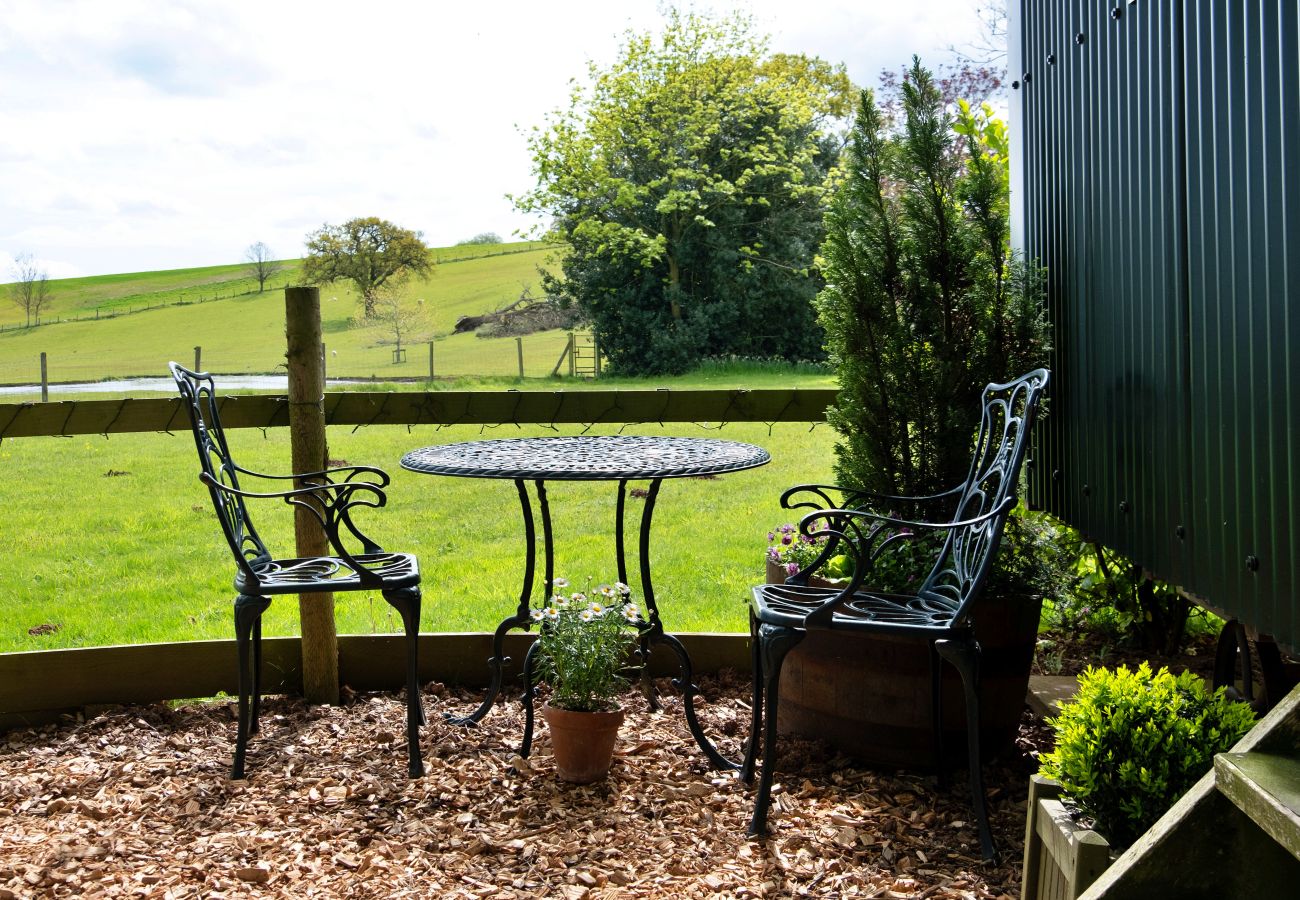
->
xmin=516 ymin=10 xmax=852 ymax=373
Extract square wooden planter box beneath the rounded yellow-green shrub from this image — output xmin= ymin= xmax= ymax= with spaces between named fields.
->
xmin=1021 ymin=775 xmax=1118 ymax=900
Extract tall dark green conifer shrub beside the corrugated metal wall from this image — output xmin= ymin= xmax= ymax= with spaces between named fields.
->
xmin=818 ymin=60 xmax=1048 ymax=496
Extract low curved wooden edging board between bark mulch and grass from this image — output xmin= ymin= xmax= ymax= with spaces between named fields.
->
xmin=0 ymin=632 xmax=750 ymax=731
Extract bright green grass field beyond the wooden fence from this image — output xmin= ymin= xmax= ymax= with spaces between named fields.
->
xmin=0 ymin=246 xmax=833 ymax=652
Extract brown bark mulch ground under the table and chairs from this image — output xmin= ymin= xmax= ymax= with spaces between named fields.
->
xmin=0 ymin=676 xmax=1047 ymax=900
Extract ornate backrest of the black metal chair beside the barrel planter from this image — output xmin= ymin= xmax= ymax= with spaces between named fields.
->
xmin=919 ymin=369 xmax=1048 ymax=624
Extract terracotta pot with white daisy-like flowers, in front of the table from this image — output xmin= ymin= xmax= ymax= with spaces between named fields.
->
xmin=532 ymin=579 xmax=644 ymax=784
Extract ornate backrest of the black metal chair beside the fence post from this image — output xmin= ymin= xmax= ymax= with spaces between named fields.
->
xmin=168 ymin=363 xmax=270 ymax=584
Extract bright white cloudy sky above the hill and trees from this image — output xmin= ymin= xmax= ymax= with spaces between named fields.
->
xmin=0 ymin=0 xmax=976 ymax=281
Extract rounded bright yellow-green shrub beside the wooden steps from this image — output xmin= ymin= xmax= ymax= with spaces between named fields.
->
xmin=1040 ymin=663 xmax=1255 ymax=847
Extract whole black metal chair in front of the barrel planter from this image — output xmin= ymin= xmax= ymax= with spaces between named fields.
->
xmin=741 ymin=369 xmax=1048 ymax=860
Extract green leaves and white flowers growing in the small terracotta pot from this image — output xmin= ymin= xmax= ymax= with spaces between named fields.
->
xmin=532 ymin=579 xmax=642 ymax=713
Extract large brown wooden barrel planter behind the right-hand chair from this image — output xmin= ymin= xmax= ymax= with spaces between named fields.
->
xmin=768 ymin=561 xmax=1041 ymax=769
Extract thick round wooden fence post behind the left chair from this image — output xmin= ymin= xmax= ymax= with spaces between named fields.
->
xmin=285 ymin=287 xmax=338 ymax=704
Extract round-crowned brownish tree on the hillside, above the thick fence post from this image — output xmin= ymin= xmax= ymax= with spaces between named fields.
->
xmin=303 ymin=216 xmax=433 ymax=319
